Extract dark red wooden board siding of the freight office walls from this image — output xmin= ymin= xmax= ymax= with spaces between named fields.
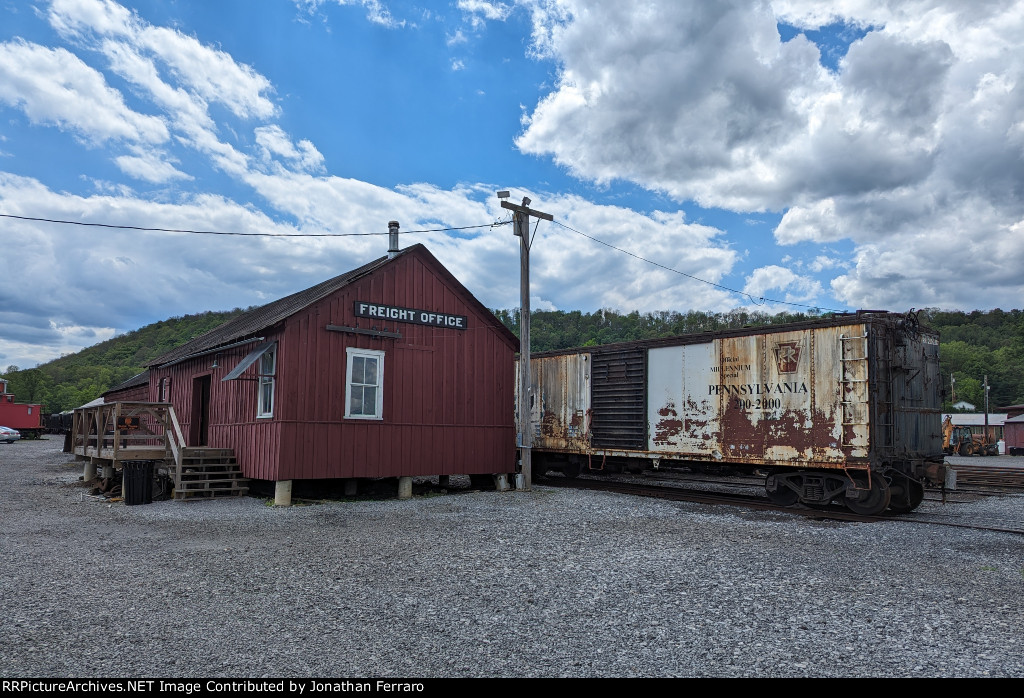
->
xmin=150 ymin=247 xmax=515 ymax=480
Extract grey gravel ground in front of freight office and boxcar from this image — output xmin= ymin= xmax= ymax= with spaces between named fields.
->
xmin=0 ymin=437 xmax=1024 ymax=679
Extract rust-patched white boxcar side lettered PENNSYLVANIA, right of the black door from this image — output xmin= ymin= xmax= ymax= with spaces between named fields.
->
xmin=648 ymin=325 xmax=868 ymax=464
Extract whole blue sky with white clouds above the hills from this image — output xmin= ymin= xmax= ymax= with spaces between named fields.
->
xmin=0 ymin=0 xmax=1024 ymax=367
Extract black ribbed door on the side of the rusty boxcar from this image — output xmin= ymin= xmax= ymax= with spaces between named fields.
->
xmin=591 ymin=347 xmax=647 ymax=448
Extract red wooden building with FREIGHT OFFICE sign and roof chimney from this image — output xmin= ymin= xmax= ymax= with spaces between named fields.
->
xmin=150 ymin=231 xmax=518 ymax=504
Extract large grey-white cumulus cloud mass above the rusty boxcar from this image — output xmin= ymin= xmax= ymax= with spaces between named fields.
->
xmin=516 ymin=0 xmax=1024 ymax=307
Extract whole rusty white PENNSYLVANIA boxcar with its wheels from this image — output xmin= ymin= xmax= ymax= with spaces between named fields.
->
xmin=520 ymin=311 xmax=955 ymax=515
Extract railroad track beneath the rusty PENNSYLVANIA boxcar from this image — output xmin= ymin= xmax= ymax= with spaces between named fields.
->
xmin=538 ymin=470 xmax=1024 ymax=535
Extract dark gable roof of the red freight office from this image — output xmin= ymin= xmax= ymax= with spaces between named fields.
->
xmin=150 ymin=244 xmax=519 ymax=366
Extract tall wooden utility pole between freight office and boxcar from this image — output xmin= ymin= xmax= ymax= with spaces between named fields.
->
xmin=498 ymin=190 xmax=554 ymax=490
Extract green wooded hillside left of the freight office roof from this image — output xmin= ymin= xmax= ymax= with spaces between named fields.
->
xmin=2 ymin=308 xmax=243 ymax=412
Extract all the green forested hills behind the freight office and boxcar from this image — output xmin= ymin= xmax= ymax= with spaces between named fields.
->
xmin=3 ymin=308 xmax=1024 ymax=411
